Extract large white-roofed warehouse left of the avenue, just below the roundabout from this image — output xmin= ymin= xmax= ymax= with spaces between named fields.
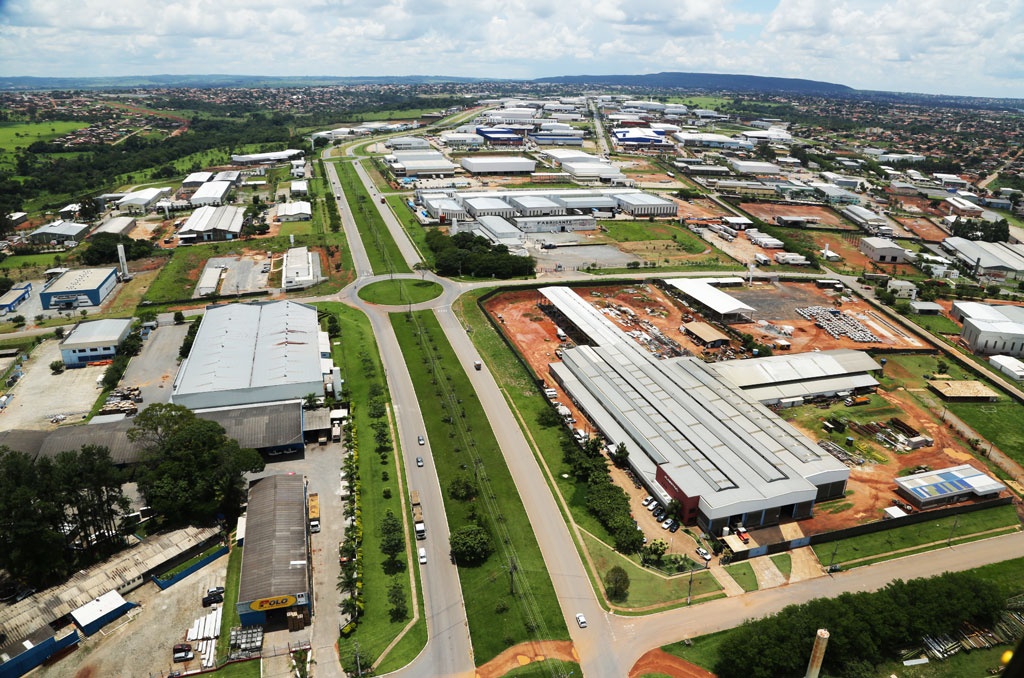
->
xmin=171 ymin=301 xmax=330 ymax=410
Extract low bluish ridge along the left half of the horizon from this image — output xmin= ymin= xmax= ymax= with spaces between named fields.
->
xmin=0 ymin=74 xmax=483 ymax=91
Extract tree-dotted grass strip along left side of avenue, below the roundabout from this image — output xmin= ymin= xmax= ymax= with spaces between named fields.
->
xmin=316 ymin=302 xmax=427 ymax=668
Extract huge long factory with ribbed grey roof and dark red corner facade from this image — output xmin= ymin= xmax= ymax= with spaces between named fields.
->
xmin=540 ymin=287 xmax=850 ymax=535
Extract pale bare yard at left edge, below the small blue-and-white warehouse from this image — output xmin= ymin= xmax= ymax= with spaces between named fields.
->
xmin=0 ymin=339 xmax=106 ymax=430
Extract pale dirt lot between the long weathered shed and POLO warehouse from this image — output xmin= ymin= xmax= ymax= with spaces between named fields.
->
xmin=33 ymin=555 xmax=227 ymax=678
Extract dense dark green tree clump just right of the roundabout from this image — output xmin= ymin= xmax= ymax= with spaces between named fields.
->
xmin=426 ymin=228 xmax=537 ymax=280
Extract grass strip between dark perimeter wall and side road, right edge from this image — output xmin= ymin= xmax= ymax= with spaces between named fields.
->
xmin=812 ymin=506 xmax=1020 ymax=565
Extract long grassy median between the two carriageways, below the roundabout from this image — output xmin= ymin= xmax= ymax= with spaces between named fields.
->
xmin=391 ymin=311 xmax=568 ymax=666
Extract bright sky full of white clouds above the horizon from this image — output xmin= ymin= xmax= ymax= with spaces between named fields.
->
xmin=6 ymin=0 xmax=1024 ymax=97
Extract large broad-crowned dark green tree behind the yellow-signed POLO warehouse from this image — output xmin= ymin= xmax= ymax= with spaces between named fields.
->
xmin=128 ymin=402 xmax=263 ymax=524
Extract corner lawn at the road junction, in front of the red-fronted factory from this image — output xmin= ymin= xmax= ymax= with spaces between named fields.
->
xmin=583 ymin=534 xmax=724 ymax=607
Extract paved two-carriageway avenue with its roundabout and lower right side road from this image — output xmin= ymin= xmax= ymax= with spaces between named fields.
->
xmin=316 ymin=134 xmax=1024 ymax=678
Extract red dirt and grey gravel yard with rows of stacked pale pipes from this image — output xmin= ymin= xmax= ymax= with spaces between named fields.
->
xmin=729 ymin=283 xmax=928 ymax=352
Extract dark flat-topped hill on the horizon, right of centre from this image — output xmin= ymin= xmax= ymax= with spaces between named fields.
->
xmin=534 ymin=73 xmax=856 ymax=94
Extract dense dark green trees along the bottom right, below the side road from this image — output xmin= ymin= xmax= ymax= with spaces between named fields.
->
xmin=714 ymin=571 xmax=1005 ymax=678
